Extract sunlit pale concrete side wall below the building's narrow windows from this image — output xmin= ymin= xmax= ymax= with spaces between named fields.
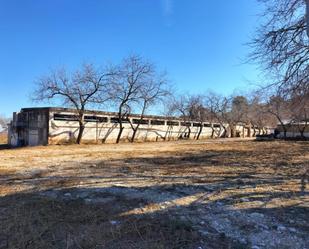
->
xmin=49 ymin=112 xmax=223 ymax=144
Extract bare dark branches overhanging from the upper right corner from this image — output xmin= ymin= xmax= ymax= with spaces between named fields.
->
xmin=250 ymin=0 xmax=309 ymax=96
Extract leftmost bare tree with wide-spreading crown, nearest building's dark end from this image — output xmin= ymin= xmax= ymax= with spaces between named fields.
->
xmin=33 ymin=64 xmax=108 ymax=144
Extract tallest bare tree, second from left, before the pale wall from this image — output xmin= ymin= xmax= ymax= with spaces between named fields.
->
xmin=111 ymin=55 xmax=154 ymax=143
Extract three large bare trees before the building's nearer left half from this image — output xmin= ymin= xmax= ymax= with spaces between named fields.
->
xmin=33 ymin=55 xmax=170 ymax=144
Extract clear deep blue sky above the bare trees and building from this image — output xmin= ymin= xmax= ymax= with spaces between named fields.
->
xmin=0 ymin=0 xmax=259 ymax=116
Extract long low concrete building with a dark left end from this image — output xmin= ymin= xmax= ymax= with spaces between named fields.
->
xmin=8 ymin=107 xmax=255 ymax=146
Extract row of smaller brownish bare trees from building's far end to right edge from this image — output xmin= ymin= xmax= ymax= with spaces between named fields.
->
xmin=171 ymin=89 xmax=309 ymax=139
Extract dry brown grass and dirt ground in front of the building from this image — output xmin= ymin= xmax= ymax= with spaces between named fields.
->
xmin=0 ymin=140 xmax=309 ymax=249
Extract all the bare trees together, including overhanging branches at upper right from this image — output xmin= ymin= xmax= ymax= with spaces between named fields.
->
xmin=25 ymin=0 xmax=309 ymax=143
